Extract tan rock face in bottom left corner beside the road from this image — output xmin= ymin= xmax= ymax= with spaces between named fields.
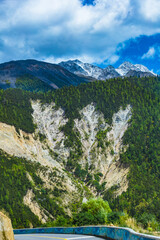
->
xmin=0 ymin=212 xmax=14 ymax=240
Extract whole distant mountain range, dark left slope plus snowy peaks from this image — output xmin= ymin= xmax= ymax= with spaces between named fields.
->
xmin=0 ymin=59 xmax=156 ymax=92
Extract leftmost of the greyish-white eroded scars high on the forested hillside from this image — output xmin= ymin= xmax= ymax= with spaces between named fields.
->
xmin=32 ymin=101 xmax=70 ymax=162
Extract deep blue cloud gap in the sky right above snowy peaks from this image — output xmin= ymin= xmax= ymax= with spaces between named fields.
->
xmin=115 ymin=34 xmax=160 ymax=74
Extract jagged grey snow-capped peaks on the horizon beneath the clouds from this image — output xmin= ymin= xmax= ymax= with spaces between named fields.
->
xmin=59 ymin=59 xmax=156 ymax=80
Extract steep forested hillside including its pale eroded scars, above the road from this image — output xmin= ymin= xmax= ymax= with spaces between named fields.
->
xmin=0 ymin=77 xmax=160 ymax=227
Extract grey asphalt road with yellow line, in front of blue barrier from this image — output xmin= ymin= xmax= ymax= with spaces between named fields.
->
xmin=15 ymin=234 xmax=102 ymax=240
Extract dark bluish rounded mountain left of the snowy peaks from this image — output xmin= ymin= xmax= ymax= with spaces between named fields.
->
xmin=0 ymin=60 xmax=91 ymax=92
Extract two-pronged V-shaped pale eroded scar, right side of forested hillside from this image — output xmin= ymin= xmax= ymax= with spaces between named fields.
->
xmin=75 ymin=104 xmax=131 ymax=195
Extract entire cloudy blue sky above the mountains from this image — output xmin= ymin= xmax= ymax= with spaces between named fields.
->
xmin=0 ymin=0 xmax=160 ymax=74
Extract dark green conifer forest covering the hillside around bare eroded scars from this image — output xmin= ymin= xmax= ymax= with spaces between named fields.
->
xmin=0 ymin=77 xmax=160 ymax=231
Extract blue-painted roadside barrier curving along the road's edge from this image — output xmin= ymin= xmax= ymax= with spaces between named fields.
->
xmin=13 ymin=226 xmax=160 ymax=240
